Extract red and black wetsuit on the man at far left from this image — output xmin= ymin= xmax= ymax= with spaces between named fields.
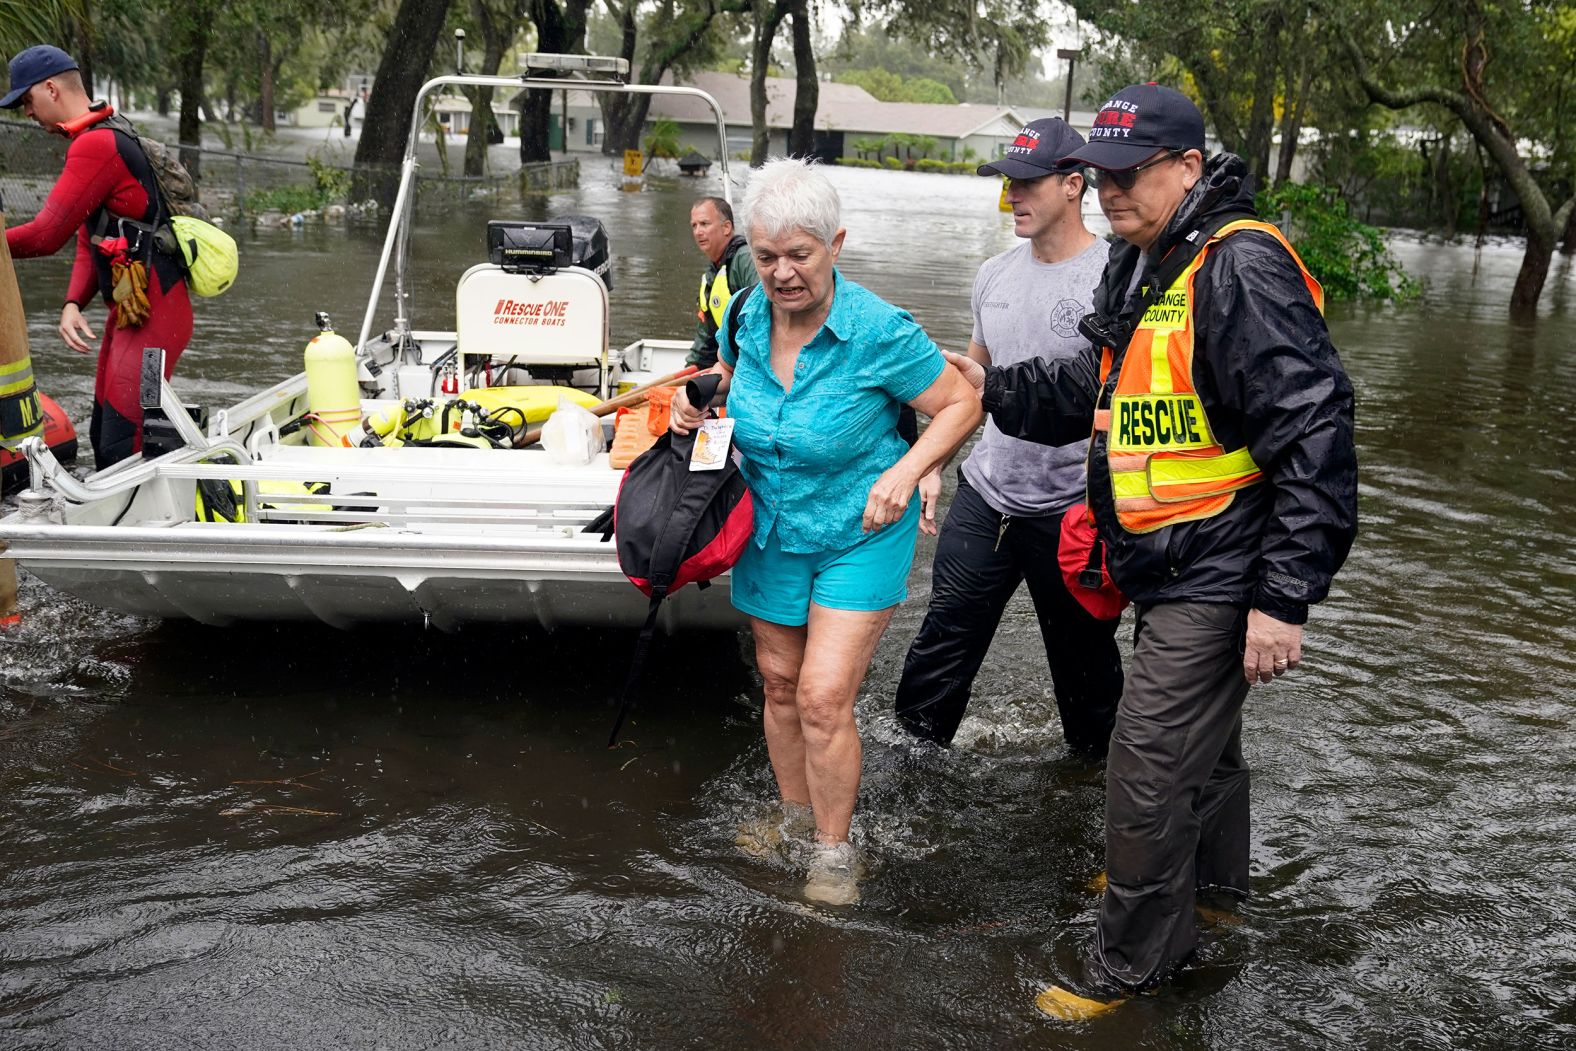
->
xmin=5 ymin=106 xmax=192 ymax=470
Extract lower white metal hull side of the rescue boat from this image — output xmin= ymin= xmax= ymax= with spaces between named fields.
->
xmin=5 ymin=523 xmax=742 ymax=633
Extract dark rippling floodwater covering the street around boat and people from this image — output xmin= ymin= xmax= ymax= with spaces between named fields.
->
xmin=0 ymin=162 xmax=1576 ymax=1049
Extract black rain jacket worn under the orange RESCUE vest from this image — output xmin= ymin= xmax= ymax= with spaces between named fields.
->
xmin=983 ymin=154 xmax=1357 ymax=624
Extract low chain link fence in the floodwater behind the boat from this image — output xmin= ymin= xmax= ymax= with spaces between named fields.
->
xmin=0 ymin=121 xmax=580 ymax=225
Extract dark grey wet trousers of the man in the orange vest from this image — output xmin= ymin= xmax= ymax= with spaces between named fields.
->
xmin=1087 ymin=602 xmax=1248 ymax=991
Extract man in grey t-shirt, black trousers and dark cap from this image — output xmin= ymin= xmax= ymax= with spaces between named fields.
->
xmin=897 ymin=117 xmax=1122 ymax=758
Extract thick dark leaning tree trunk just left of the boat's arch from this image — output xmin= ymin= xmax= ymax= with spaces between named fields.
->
xmin=351 ymin=0 xmax=449 ymax=208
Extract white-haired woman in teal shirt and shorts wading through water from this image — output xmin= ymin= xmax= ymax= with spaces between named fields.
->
xmin=673 ymin=159 xmax=980 ymax=904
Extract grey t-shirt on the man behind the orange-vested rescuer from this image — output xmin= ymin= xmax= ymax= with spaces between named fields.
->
xmin=963 ymin=238 xmax=1110 ymax=517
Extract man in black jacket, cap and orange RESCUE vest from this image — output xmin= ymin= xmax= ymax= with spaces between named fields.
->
xmin=947 ymin=84 xmax=1357 ymax=1019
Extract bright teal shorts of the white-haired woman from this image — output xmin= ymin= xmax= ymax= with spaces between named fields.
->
xmin=730 ymin=496 xmax=919 ymax=627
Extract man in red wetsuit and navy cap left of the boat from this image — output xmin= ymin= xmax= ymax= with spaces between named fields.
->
xmin=0 ymin=44 xmax=192 ymax=470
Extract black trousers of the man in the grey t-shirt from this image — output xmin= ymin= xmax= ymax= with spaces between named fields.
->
xmin=897 ymin=471 xmax=1122 ymax=758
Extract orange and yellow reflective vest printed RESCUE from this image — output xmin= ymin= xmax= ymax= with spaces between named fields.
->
xmin=1094 ymin=219 xmax=1324 ymax=533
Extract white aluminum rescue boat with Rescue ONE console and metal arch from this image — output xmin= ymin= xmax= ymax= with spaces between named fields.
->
xmin=0 ymin=55 xmax=742 ymax=632
